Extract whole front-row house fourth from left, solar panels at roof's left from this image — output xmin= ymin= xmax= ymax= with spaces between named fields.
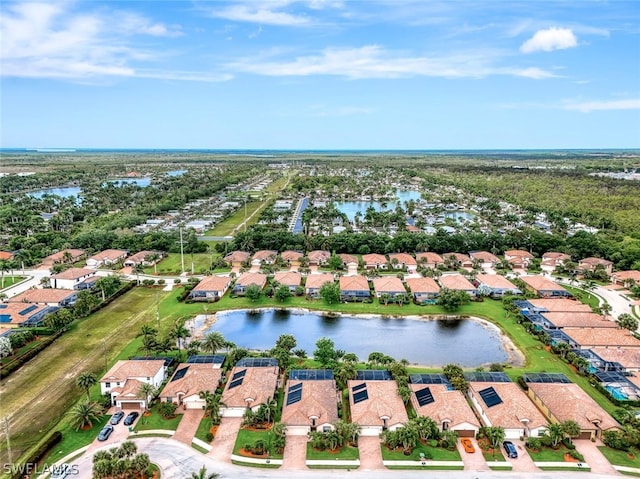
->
xmin=281 ymin=374 xmax=341 ymax=436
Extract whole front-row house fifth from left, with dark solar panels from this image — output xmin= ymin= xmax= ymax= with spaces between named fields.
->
xmin=347 ymin=379 xmax=409 ymax=437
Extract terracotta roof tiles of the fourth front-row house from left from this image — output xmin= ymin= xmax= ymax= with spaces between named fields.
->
xmin=282 ymin=379 xmax=339 ymax=426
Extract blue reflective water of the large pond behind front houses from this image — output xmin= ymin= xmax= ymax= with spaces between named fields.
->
xmin=205 ymin=306 xmax=508 ymax=367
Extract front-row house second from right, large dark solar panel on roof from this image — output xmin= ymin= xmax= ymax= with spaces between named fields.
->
xmin=465 ymin=373 xmax=547 ymax=439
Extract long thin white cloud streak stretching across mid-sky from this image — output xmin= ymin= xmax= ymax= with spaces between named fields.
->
xmin=227 ymin=45 xmax=555 ymax=79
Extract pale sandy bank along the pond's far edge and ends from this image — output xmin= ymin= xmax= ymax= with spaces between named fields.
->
xmin=185 ymin=307 xmax=525 ymax=369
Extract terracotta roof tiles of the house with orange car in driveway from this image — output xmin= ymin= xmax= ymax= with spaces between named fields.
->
xmin=409 ymin=384 xmax=480 ymax=434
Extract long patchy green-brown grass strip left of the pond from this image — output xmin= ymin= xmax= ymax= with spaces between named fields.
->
xmin=0 ymin=288 xmax=166 ymax=462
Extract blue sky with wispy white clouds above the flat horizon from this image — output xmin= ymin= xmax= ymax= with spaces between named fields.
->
xmin=0 ymin=0 xmax=640 ymax=149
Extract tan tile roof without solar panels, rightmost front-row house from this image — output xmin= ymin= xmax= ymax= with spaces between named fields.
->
xmin=528 ymin=383 xmax=620 ymax=431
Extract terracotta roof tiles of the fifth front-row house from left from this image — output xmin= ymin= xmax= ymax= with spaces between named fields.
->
xmin=348 ymin=380 xmax=409 ymax=427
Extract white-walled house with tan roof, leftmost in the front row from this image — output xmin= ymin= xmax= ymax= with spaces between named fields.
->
xmin=100 ymin=359 xmax=167 ymax=409
